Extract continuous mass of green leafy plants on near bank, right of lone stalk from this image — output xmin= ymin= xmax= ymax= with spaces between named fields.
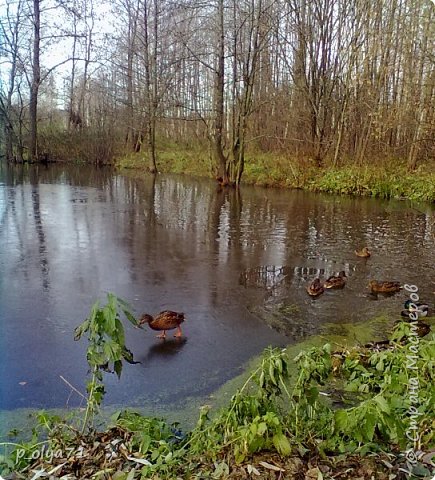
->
xmin=106 ymin=327 xmax=435 ymax=478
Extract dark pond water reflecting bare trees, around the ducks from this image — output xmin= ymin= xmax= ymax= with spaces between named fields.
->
xmin=0 ymin=164 xmax=435 ymax=410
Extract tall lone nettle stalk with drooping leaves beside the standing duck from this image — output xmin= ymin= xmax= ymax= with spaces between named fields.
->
xmin=74 ymin=293 xmax=138 ymax=433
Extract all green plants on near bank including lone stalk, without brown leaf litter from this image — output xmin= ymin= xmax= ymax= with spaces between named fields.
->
xmin=0 ymin=294 xmax=435 ymax=479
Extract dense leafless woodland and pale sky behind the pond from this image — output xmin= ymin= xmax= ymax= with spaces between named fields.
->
xmin=0 ymin=0 xmax=435 ymax=183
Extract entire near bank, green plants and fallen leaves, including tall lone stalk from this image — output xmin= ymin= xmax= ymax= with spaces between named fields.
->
xmin=0 ymin=295 xmax=435 ymax=480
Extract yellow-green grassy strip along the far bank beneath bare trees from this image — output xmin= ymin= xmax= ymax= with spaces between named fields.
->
xmin=118 ymin=144 xmax=435 ymax=202
